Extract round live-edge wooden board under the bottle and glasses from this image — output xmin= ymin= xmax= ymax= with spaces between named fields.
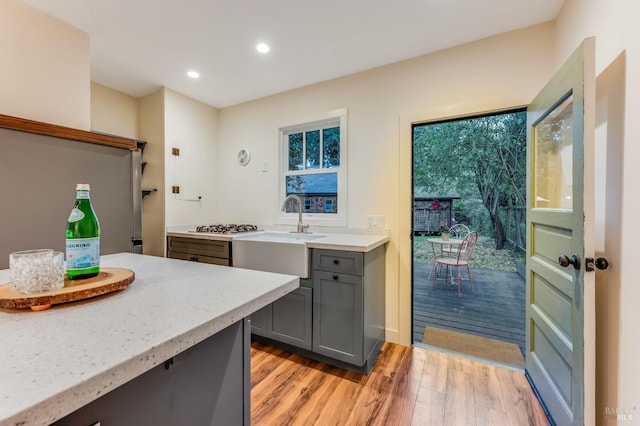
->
xmin=0 ymin=268 xmax=135 ymax=311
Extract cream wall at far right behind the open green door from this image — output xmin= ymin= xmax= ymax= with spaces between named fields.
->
xmin=555 ymin=0 xmax=640 ymax=424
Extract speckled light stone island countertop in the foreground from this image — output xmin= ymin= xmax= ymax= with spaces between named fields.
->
xmin=0 ymin=253 xmax=299 ymax=425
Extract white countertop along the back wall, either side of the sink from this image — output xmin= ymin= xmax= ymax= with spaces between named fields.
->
xmin=167 ymin=226 xmax=389 ymax=253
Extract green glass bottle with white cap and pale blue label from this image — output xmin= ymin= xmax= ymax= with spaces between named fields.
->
xmin=66 ymin=183 xmax=100 ymax=280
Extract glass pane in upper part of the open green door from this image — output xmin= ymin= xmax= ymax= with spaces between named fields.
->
xmin=533 ymin=96 xmax=573 ymax=210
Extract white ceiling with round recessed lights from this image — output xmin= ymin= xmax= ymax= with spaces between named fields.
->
xmin=23 ymin=0 xmax=564 ymax=107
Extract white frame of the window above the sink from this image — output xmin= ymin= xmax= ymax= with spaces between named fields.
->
xmin=276 ymin=109 xmax=348 ymax=227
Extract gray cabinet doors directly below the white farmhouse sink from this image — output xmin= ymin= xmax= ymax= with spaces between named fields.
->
xmin=251 ymin=280 xmax=313 ymax=349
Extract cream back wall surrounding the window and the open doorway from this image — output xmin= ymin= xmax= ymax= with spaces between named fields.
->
xmin=216 ymin=24 xmax=554 ymax=344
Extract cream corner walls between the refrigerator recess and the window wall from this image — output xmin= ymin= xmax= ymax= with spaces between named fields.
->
xmin=91 ymin=83 xmax=218 ymax=256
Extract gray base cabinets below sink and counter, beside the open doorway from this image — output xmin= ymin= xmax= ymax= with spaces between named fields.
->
xmin=251 ymin=246 xmax=385 ymax=373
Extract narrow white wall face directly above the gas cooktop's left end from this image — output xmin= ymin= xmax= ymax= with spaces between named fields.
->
xmin=164 ymin=89 xmax=220 ymax=226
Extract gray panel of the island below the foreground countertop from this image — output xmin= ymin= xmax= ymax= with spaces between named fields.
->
xmin=54 ymin=320 xmax=251 ymax=426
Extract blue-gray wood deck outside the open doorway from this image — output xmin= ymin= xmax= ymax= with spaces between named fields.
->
xmin=413 ymin=262 xmax=525 ymax=354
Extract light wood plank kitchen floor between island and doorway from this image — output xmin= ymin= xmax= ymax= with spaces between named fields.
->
xmin=251 ymin=342 xmax=549 ymax=426
